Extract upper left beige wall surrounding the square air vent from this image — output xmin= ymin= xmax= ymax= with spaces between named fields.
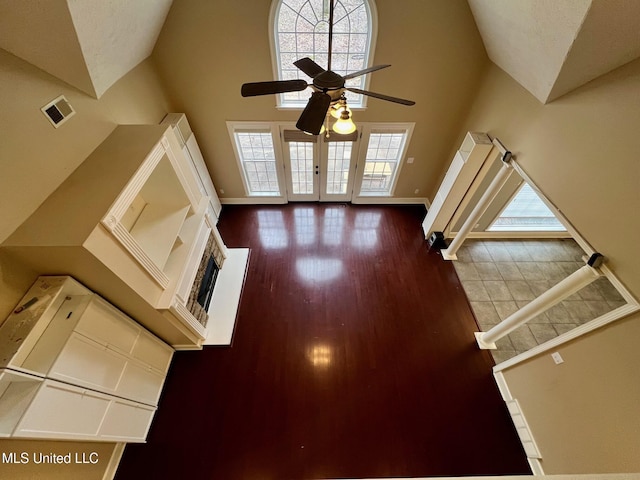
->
xmin=0 ymin=49 xmax=169 ymax=246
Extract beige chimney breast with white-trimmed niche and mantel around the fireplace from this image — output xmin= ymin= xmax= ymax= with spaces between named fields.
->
xmin=3 ymin=124 xmax=238 ymax=349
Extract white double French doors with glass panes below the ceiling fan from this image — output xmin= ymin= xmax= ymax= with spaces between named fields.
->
xmin=281 ymin=129 xmax=358 ymax=202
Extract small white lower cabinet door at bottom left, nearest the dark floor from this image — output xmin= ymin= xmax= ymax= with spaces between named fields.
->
xmin=100 ymin=399 xmax=155 ymax=442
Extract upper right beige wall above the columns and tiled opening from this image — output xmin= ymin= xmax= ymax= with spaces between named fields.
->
xmin=458 ymin=60 xmax=640 ymax=297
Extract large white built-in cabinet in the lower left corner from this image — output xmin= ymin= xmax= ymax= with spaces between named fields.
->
xmin=0 ymin=277 xmax=173 ymax=442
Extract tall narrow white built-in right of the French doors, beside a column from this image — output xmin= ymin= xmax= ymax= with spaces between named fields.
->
xmin=422 ymin=132 xmax=493 ymax=238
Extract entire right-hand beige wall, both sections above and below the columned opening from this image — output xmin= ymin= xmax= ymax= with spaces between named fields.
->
xmin=459 ymin=60 xmax=640 ymax=473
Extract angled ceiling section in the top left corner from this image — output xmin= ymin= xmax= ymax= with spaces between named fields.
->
xmin=0 ymin=0 xmax=172 ymax=98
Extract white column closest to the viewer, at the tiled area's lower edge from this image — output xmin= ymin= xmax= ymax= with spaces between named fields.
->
xmin=475 ymin=253 xmax=602 ymax=350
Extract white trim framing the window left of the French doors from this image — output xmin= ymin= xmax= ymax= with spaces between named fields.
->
xmin=227 ymin=121 xmax=286 ymax=203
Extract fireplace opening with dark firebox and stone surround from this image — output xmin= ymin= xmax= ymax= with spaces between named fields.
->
xmin=186 ymin=234 xmax=224 ymax=327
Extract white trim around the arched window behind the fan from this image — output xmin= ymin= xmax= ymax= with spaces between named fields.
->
xmin=267 ymin=0 xmax=378 ymax=111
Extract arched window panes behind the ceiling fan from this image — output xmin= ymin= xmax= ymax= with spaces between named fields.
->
xmin=271 ymin=0 xmax=376 ymax=108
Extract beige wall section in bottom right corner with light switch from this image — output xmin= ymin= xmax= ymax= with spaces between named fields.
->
xmin=505 ymin=314 xmax=640 ymax=474
